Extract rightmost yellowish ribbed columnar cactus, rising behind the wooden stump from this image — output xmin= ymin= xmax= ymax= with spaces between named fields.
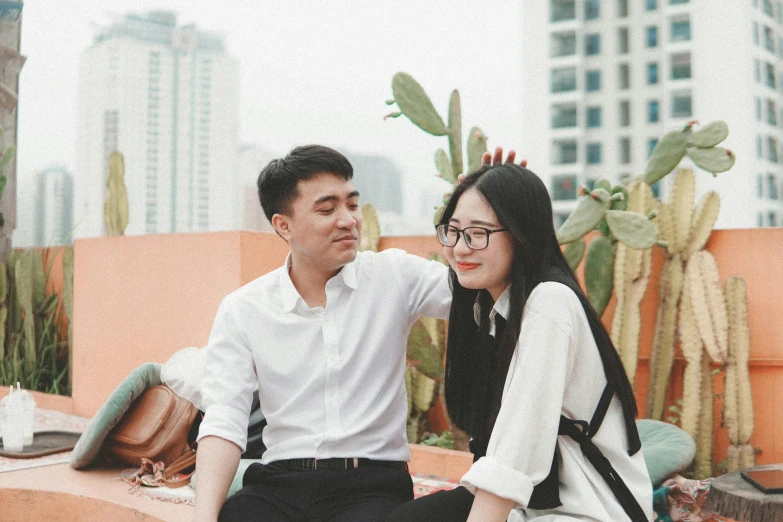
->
xmin=723 ymin=276 xmax=755 ymax=471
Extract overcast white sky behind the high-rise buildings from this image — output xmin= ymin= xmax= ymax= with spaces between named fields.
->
xmin=14 ymin=0 xmax=522 ymax=244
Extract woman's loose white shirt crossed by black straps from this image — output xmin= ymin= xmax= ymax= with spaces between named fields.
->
xmin=461 ymin=282 xmax=653 ymax=522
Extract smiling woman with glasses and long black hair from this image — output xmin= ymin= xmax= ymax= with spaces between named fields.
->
xmin=389 ymin=163 xmax=653 ymax=522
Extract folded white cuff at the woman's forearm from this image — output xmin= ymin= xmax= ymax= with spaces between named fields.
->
xmin=460 ymin=457 xmax=533 ymax=508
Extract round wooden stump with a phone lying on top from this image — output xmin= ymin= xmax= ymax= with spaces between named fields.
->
xmin=707 ymin=464 xmax=783 ymax=522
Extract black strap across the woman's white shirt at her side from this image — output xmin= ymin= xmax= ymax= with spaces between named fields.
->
xmin=557 ymin=384 xmax=648 ymax=522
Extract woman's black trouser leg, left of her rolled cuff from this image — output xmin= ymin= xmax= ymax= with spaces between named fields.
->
xmin=388 ymin=486 xmax=475 ymax=522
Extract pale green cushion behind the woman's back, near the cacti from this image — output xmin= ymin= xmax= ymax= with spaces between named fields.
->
xmin=636 ymin=419 xmax=696 ymax=486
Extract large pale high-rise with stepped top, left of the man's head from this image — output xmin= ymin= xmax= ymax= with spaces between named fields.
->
xmin=74 ymin=11 xmax=241 ymax=237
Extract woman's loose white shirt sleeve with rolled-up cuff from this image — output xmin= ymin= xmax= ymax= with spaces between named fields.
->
xmin=461 ymin=310 xmax=571 ymax=508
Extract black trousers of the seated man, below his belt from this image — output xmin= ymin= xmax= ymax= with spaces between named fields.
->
xmin=218 ymin=464 xmax=413 ymax=522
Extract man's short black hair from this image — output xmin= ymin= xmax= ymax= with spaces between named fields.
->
xmin=257 ymin=145 xmax=353 ymax=221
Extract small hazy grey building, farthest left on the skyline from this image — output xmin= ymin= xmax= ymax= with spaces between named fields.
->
xmin=33 ymin=167 xmax=73 ymax=246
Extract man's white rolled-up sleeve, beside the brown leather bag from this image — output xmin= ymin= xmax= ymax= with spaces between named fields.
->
xmin=198 ymin=298 xmax=257 ymax=452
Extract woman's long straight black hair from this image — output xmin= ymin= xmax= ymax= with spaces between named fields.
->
xmin=440 ymin=163 xmax=640 ymax=454
